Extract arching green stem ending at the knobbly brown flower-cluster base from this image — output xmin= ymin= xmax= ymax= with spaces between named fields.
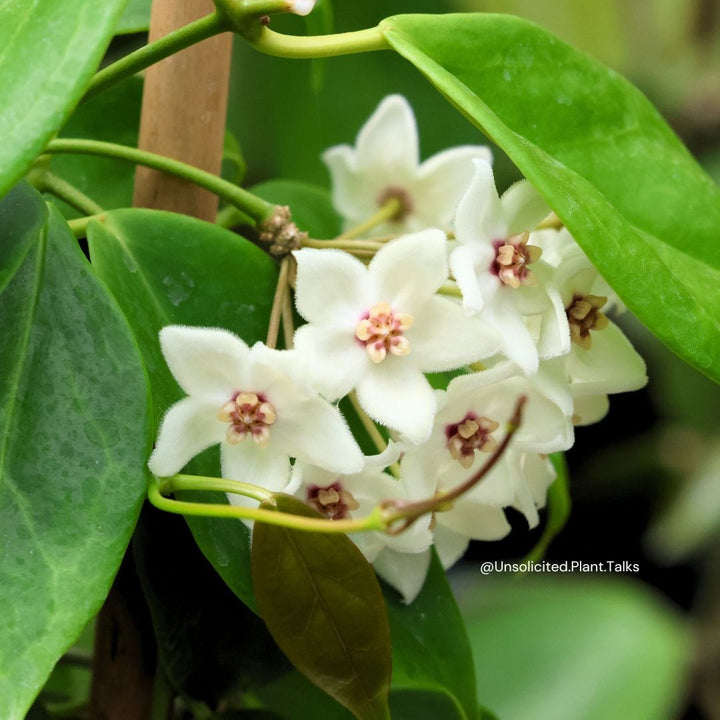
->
xmin=44 ymin=138 xmax=275 ymax=224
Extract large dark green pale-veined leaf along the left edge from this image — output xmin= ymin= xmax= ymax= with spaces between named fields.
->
xmin=0 ymin=185 xmax=150 ymax=720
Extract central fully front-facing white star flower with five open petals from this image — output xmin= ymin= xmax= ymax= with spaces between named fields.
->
xmin=295 ymin=230 xmax=499 ymax=443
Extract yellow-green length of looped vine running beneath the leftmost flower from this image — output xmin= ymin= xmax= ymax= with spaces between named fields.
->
xmin=148 ymin=479 xmax=385 ymax=534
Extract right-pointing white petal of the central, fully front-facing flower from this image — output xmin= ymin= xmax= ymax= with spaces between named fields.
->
xmin=406 ymin=297 xmax=500 ymax=372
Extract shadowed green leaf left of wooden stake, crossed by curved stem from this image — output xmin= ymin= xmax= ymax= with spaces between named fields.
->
xmin=50 ymin=77 xmax=143 ymax=217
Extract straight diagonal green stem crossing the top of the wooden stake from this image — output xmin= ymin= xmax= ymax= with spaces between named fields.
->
xmin=85 ymin=12 xmax=231 ymax=98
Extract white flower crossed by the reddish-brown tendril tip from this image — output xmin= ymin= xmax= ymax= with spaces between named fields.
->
xmin=401 ymin=363 xmax=573 ymax=566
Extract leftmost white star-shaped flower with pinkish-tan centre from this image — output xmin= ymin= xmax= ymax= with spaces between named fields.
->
xmin=148 ymin=325 xmax=363 ymax=491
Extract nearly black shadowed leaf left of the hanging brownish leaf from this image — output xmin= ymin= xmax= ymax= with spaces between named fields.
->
xmin=132 ymin=506 xmax=289 ymax=707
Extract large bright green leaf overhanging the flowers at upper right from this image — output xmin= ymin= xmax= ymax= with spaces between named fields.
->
xmin=381 ymin=14 xmax=720 ymax=380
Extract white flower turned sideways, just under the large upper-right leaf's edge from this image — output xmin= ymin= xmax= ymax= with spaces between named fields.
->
xmin=450 ymin=160 xmax=557 ymax=374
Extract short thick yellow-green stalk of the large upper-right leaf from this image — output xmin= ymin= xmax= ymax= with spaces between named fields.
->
xmin=246 ymin=27 xmax=390 ymax=58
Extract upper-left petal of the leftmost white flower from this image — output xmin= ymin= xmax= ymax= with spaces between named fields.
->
xmin=160 ymin=325 xmax=249 ymax=403
